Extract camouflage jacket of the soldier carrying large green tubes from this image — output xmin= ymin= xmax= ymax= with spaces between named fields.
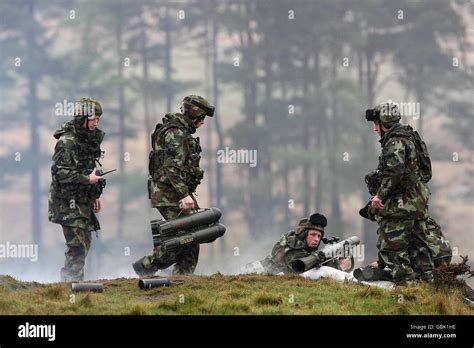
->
xmin=148 ymin=113 xmax=204 ymax=207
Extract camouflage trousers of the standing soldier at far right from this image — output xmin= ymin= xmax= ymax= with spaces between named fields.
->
xmin=377 ymin=219 xmax=433 ymax=282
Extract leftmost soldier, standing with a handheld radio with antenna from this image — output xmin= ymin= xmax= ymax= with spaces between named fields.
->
xmin=48 ymin=98 xmax=105 ymax=281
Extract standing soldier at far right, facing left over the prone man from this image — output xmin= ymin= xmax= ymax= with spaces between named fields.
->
xmin=361 ymin=103 xmax=450 ymax=283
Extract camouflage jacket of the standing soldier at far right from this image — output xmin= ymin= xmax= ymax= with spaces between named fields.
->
xmin=376 ymin=124 xmax=430 ymax=220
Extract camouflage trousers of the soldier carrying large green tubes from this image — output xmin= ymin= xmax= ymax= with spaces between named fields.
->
xmin=141 ymin=207 xmax=199 ymax=274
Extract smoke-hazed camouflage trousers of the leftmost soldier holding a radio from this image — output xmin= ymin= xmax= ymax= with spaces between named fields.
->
xmin=61 ymin=225 xmax=92 ymax=281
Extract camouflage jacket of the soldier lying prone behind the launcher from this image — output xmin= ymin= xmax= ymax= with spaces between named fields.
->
xmin=262 ymin=231 xmax=339 ymax=274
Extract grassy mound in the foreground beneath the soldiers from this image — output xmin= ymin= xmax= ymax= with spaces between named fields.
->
xmin=0 ymin=275 xmax=474 ymax=315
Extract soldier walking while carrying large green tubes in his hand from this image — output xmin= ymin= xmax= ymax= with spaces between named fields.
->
xmin=133 ymin=95 xmax=214 ymax=276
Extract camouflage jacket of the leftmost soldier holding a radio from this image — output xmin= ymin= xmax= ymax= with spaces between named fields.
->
xmin=48 ymin=120 xmax=105 ymax=231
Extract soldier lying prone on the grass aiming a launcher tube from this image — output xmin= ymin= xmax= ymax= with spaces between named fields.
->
xmin=261 ymin=213 xmax=347 ymax=274
